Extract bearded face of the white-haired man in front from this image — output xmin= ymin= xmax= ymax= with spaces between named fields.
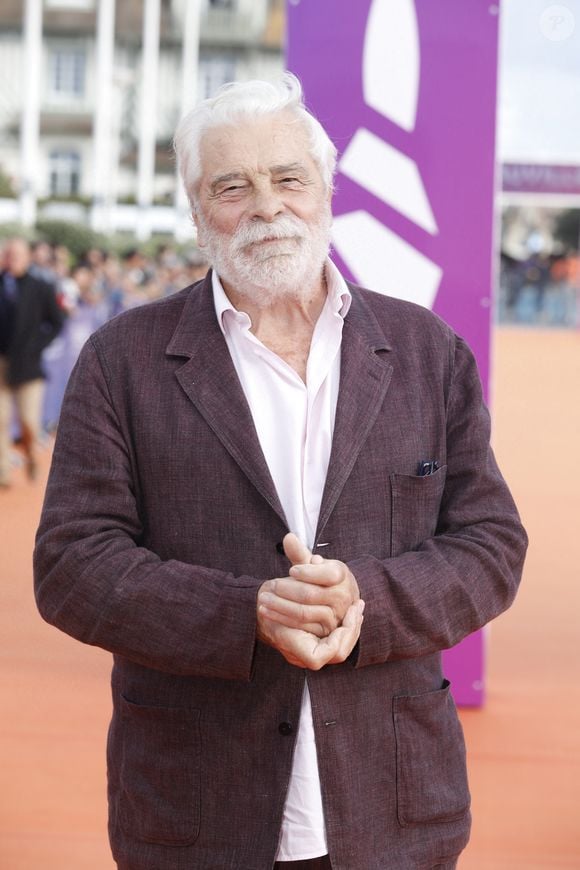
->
xmin=195 ymin=112 xmax=331 ymax=305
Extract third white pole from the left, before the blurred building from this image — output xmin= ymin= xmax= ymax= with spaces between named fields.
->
xmin=137 ymin=0 xmax=160 ymax=241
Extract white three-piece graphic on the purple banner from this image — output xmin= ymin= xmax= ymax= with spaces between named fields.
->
xmin=332 ymin=0 xmax=442 ymax=308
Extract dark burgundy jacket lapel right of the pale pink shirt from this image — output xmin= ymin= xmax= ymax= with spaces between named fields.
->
xmin=316 ymin=285 xmax=393 ymax=541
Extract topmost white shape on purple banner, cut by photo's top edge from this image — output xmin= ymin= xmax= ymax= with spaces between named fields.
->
xmin=362 ymin=0 xmax=420 ymax=131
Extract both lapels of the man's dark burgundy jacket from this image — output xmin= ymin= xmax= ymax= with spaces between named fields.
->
xmin=166 ymin=272 xmax=393 ymax=539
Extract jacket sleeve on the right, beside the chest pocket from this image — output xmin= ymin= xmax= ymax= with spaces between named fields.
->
xmin=349 ymin=339 xmax=527 ymax=667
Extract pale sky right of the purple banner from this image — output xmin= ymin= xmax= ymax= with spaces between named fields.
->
xmin=498 ymin=0 xmax=580 ymax=164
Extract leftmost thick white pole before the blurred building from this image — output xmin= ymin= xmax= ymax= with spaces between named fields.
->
xmin=20 ymin=0 xmax=42 ymax=227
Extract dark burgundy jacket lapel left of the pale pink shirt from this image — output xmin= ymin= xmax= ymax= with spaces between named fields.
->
xmin=166 ymin=272 xmax=287 ymax=526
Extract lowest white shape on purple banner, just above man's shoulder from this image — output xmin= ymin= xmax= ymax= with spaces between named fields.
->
xmin=332 ymin=210 xmax=443 ymax=308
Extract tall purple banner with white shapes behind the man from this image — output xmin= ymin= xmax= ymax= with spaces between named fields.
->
xmin=287 ymin=0 xmax=499 ymax=705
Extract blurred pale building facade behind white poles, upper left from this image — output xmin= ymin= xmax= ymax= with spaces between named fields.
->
xmin=0 ymin=0 xmax=283 ymax=238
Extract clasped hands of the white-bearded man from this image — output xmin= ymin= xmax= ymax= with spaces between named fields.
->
xmin=257 ymin=532 xmax=364 ymax=671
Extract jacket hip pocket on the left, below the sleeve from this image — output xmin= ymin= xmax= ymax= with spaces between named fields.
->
xmin=119 ymin=697 xmax=201 ymax=846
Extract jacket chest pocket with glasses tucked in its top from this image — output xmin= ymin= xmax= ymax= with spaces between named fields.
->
xmin=390 ymin=465 xmax=447 ymax=556
